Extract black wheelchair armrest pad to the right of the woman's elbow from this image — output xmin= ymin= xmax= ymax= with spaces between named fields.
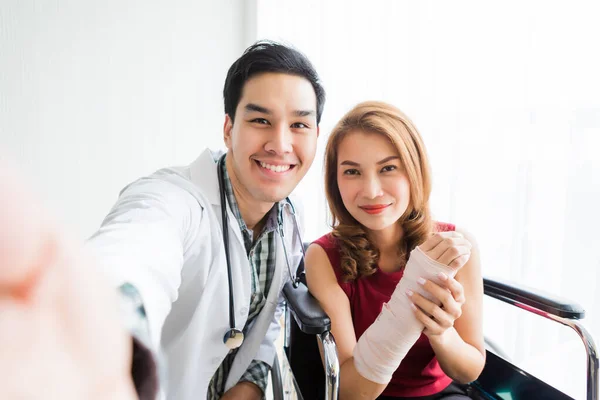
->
xmin=483 ymin=278 xmax=585 ymax=319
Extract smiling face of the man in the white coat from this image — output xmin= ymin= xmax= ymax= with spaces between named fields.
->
xmin=224 ymin=73 xmax=319 ymax=208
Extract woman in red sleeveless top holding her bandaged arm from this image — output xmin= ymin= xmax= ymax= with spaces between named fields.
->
xmin=305 ymin=102 xmax=485 ymax=400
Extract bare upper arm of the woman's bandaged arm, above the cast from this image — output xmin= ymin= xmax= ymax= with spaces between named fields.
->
xmin=304 ymin=244 xmax=387 ymax=400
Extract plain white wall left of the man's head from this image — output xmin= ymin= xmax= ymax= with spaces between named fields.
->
xmin=0 ymin=0 xmax=248 ymax=238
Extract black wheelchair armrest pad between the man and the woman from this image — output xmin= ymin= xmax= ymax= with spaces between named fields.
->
xmin=283 ymin=282 xmax=331 ymax=335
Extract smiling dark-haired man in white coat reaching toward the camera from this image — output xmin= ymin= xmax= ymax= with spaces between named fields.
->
xmin=0 ymin=42 xmax=325 ymax=400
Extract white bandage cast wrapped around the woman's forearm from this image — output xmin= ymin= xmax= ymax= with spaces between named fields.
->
xmin=354 ymin=247 xmax=456 ymax=384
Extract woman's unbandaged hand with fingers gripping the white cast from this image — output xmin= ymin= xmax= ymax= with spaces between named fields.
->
xmin=407 ymin=273 xmax=465 ymax=340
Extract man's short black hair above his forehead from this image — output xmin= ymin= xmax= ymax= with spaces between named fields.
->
xmin=223 ymin=40 xmax=325 ymax=124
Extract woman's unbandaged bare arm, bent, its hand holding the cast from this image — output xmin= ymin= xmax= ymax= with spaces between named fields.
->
xmin=413 ymin=228 xmax=485 ymax=383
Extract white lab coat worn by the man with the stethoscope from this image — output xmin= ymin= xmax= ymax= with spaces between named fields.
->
xmin=87 ymin=150 xmax=301 ymax=400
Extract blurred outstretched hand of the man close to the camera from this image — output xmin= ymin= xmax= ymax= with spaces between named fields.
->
xmin=0 ymin=164 xmax=137 ymax=400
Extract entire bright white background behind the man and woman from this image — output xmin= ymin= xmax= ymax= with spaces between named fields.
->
xmin=0 ymin=0 xmax=600 ymax=398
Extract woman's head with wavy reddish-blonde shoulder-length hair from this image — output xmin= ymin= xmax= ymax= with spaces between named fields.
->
xmin=325 ymin=102 xmax=431 ymax=276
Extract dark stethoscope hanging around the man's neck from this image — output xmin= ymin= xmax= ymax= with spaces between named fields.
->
xmin=217 ymin=154 xmax=305 ymax=350
